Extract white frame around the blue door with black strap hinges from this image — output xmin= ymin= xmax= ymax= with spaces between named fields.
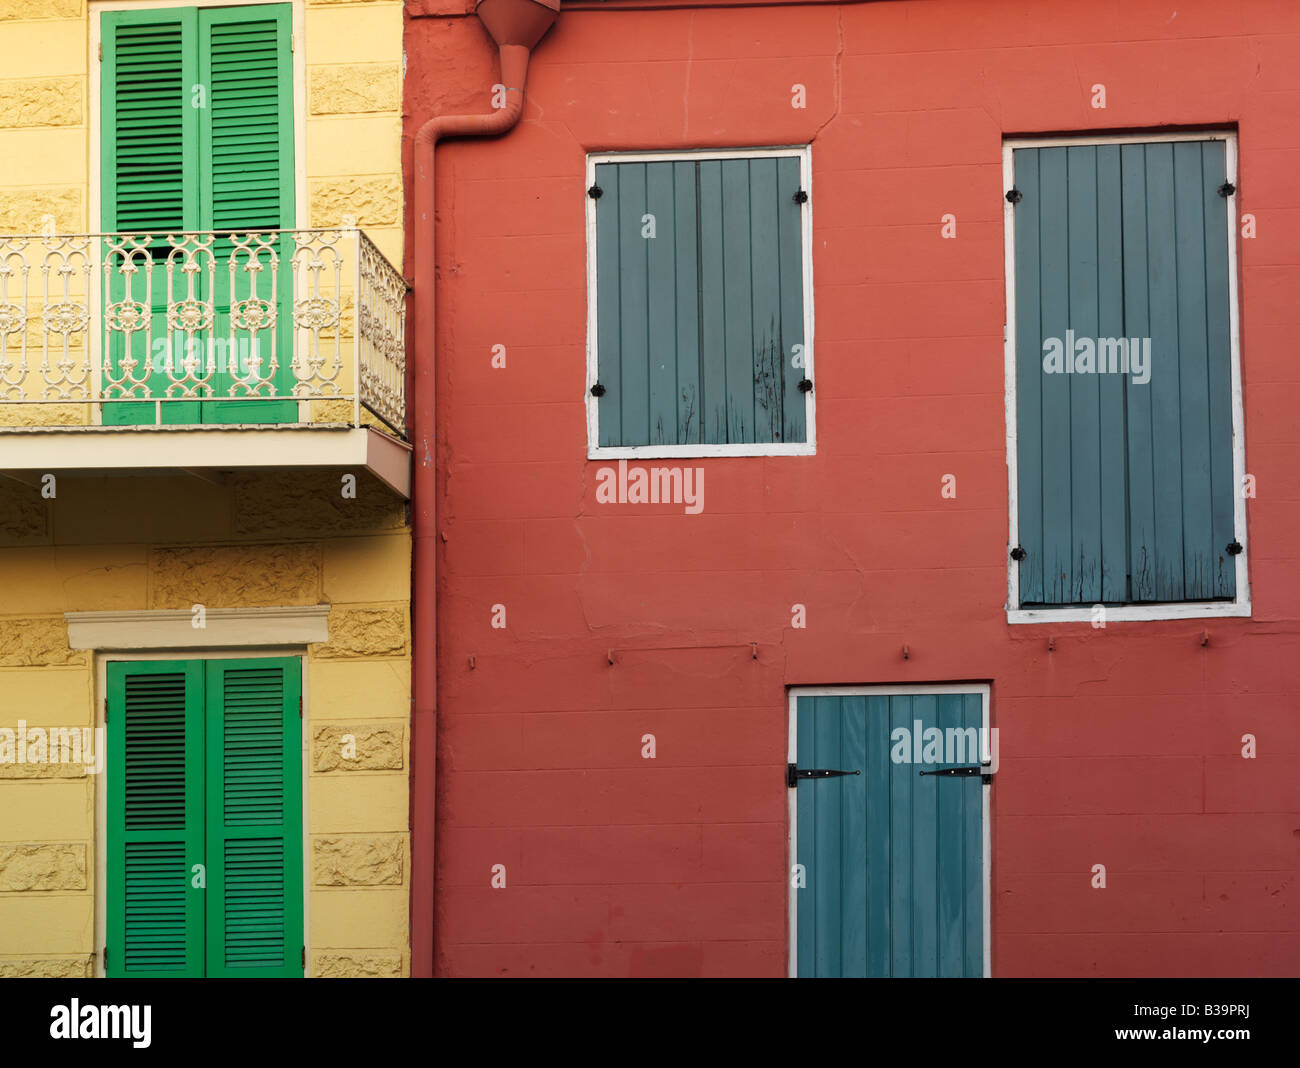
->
xmin=785 ymin=682 xmax=993 ymax=978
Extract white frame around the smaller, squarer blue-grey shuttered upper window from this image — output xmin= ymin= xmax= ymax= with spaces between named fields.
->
xmin=585 ymin=144 xmax=816 ymax=460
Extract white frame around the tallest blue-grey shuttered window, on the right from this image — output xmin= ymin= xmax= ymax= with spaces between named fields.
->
xmin=1002 ymin=130 xmax=1251 ymax=624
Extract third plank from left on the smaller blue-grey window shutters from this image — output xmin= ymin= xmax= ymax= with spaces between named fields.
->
xmin=644 ymin=162 xmax=680 ymax=444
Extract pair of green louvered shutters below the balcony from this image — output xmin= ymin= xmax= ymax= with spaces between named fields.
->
xmin=105 ymin=657 xmax=304 ymax=977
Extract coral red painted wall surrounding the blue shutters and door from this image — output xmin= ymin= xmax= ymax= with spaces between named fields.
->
xmin=406 ymin=0 xmax=1300 ymax=976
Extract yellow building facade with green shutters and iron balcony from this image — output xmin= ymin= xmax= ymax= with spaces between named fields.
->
xmin=0 ymin=0 xmax=411 ymax=976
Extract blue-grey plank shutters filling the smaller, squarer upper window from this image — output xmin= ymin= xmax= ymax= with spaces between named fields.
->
xmin=595 ymin=156 xmax=806 ymax=446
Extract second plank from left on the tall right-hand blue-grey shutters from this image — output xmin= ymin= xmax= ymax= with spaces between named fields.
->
xmin=1031 ymin=148 xmax=1074 ymax=604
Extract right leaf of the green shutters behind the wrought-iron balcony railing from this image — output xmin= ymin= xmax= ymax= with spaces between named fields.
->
xmin=199 ymin=4 xmax=298 ymax=422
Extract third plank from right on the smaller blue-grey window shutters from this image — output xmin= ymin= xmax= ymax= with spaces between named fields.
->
xmin=722 ymin=160 xmax=757 ymax=444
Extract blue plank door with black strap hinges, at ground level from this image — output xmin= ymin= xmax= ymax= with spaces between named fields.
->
xmin=790 ymin=691 xmax=984 ymax=977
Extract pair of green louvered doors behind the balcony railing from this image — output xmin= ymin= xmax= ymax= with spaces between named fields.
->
xmin=100 ymin=4 xmax=298 ymax=424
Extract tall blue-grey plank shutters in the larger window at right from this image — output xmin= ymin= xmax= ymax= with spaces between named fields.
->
xmin=1015 ymin=142 xmax=1236 ymax=605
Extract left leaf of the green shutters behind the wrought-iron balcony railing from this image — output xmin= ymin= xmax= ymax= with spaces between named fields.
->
xmin=100 ymin=8 xmax=199 ymax=425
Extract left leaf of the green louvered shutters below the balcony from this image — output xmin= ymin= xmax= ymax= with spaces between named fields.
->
xmin=107 ymin=660 xmax=204 ymax=977
